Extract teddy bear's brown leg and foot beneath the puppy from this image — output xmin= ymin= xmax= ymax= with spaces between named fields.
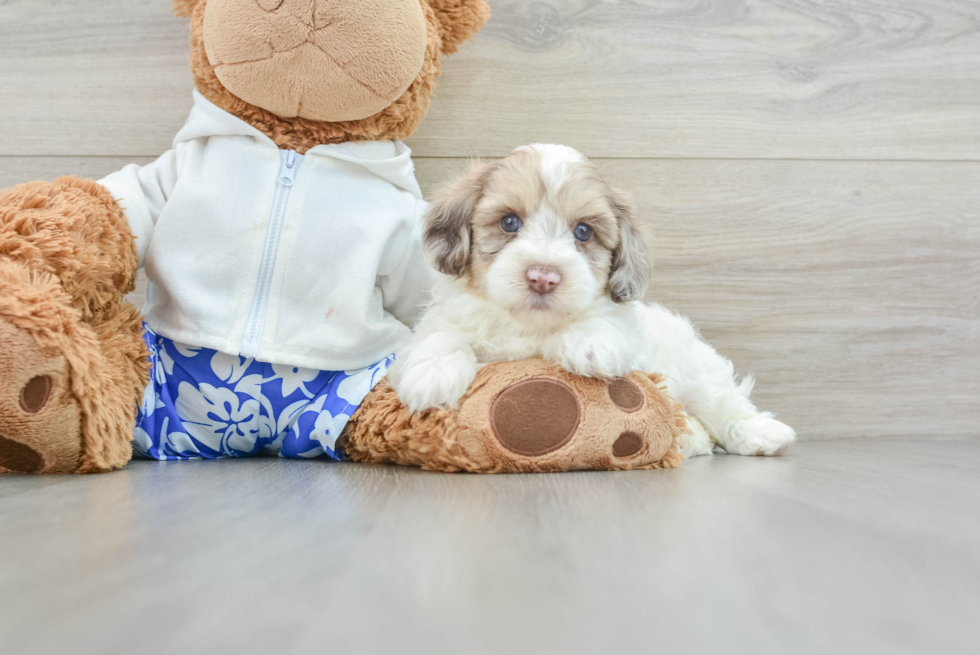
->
xmin=340 ymin=359 xmax=686 ymax=473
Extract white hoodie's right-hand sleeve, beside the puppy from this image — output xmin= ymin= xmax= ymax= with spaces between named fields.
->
xmin=378 ymin=201 xmax=432 ymax=328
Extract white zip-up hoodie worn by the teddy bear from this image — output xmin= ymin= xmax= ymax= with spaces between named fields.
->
xmin=101 ymin=91 xmax=430 ymax=371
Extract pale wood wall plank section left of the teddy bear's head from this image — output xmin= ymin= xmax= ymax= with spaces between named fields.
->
xmin=0 ymin=0 xmax=193 ymax=156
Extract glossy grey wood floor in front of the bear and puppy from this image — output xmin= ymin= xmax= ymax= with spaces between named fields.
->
xmin=0 ymin=440 xmax=980 ymax=655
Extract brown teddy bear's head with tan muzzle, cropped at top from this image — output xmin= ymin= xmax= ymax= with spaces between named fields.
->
xmin=173 ymin=0 xmax=490 ymax=152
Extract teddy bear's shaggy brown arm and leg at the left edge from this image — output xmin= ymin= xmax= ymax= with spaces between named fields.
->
xmin=0 ymin=177 xmax=149 ymax=473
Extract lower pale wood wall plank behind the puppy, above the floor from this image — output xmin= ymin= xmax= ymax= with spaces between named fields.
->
xmin=0 ymin=157 xmax=980 ymax=439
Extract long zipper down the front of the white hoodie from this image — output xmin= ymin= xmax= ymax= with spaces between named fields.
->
xmin=239 ymin=150 xmax=303 ymax=358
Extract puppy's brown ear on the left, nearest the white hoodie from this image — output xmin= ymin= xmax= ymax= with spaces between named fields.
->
xmin=422 ymin=162 xmax=494 ymax=277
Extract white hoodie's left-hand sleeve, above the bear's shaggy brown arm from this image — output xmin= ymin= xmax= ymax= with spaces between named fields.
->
xmin=99 ymin=150 xmax=177 ymax=268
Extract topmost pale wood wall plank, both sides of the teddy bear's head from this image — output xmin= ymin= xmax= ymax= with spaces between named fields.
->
xmin=0 ymin=0 xmax=980 ymax=160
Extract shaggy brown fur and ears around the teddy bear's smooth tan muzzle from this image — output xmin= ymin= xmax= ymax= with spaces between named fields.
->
xmin=182 ymin=0 xmax=490 ymax=154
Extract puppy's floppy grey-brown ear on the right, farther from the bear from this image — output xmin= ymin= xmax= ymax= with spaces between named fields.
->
xmin=609 ymin=189 xmax=653 ymax=302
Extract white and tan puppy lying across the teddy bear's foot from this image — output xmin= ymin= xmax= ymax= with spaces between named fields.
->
xmin=391 ymin=145 xmax=796 ymax=456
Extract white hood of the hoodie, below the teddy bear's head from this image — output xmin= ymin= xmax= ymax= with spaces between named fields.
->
xmin=174 ymin=90 xmax=422 ymax=199
